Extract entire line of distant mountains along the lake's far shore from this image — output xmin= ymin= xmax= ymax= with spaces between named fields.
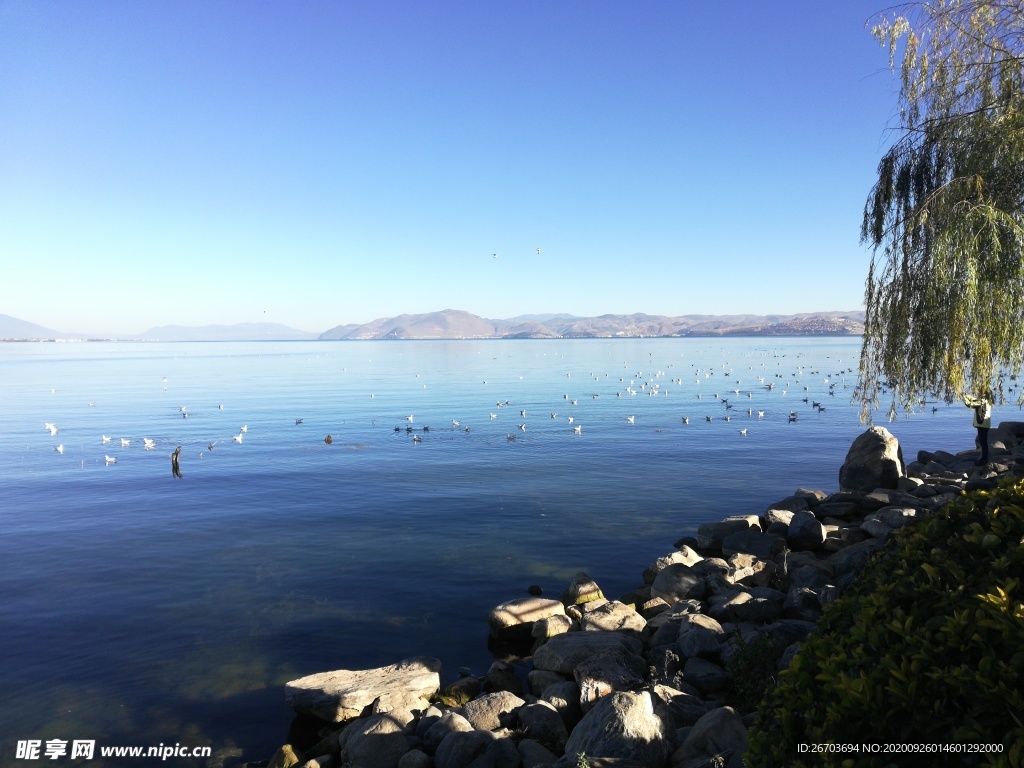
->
xmin=0 ymin=309 xmax=864 ymax=341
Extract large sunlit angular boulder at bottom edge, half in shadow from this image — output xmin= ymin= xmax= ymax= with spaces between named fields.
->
xmin=561 ymin=691 xmax=673 ymax=768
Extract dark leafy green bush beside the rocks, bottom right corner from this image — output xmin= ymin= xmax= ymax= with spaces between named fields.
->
xmin=746 ymin=480 xmax=1024 ymax=768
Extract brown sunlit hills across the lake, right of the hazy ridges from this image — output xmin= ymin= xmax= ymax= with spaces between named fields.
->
xmin=319 ymin=309 xmax=864 ymax=340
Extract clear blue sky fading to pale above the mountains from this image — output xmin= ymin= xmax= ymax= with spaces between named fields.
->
xmin=0 ymin=0 xmax=898 ymax=334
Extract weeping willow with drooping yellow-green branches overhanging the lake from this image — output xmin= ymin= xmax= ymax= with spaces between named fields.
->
xmin=855 ymin=0 xmax=1024 ymax=419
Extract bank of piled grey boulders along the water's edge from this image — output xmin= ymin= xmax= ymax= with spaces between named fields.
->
xmin=248 ymin=422 xmax=1024 ymax=768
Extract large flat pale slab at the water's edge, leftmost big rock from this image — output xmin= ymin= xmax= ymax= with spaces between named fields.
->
xmin=285 ymin=656 xmax=441 ymax=723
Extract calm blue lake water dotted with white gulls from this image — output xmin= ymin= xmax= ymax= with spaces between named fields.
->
xmin=0 ymin=338 xmax=974 ymax=766
